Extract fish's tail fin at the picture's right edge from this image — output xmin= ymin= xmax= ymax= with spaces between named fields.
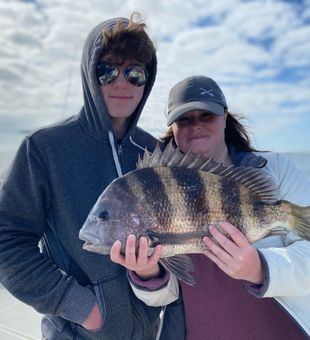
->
xmin=284 ymin=202 xmax=310 ymax=241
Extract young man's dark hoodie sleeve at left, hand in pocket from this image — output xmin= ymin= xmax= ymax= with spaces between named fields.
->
xmin=0 ymin=138 xmax=96 ymax=324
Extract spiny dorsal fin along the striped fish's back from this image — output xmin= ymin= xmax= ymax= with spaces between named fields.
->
xmin=137 ymin=140 xmax=279 ymax=204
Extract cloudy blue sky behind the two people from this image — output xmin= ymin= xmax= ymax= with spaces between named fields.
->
xmin=0 ymin=0 xmax=310 ymax=173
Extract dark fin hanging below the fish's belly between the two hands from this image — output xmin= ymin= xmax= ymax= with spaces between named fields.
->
xmin=159 ymin=254 xmax=196 ymax=287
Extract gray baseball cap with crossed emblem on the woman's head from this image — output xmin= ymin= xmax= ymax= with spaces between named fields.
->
xmin=166 ymin=76 xmax=227 ymax=126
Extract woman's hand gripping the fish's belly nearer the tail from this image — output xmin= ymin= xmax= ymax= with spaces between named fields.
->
xmin=203 ymin=222 xmax=263 ymax=284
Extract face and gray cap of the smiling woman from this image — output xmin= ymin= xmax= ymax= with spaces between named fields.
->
xmin=165 ymin=76 xmax=230 ymax=165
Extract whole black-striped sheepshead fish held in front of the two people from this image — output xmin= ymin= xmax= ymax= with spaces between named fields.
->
xmin=79 ymin=143 xmax=310 ymax=285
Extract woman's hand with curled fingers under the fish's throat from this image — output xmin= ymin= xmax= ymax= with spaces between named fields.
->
xmin=110 ymin=235 xmax=162 ymax=280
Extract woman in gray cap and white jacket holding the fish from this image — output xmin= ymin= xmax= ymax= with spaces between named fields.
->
xmin=115 ymin=76 xmax=310 ymax=340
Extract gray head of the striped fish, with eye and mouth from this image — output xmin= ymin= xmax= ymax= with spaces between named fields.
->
xmin=79 ymin=177 xmax=152 ymax=255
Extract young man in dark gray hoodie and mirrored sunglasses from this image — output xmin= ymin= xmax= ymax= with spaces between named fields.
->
xmin=0 ymin=14 xmax=161 ymax=340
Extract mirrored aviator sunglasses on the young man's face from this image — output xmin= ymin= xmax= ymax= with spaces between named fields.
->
xmin=97 ymin=64 xmax=148 ymax=86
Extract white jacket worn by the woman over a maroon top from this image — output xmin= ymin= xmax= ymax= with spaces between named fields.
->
xmin=131 ymin=152 xmax=310 ymax=335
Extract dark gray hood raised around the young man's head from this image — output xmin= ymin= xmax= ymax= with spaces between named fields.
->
xmin=79 ymin=18 xmax=157 ymax=140
